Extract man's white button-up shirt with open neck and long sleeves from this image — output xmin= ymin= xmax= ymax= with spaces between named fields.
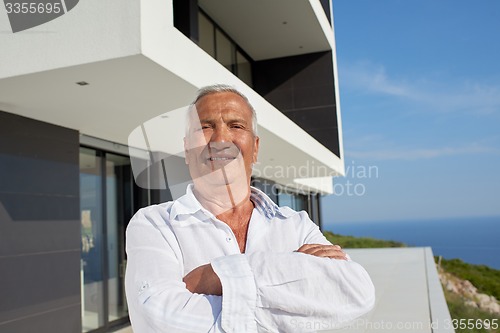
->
xmin=125 ymin=185 xmax=375 ymax=333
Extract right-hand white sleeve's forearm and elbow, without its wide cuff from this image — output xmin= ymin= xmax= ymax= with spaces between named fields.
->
xmin=248 ymin=253 xmax=375 ymax=332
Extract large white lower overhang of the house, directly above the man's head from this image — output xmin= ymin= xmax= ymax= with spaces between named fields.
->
xmin=0 ymin=0 xmax=343 ymax=193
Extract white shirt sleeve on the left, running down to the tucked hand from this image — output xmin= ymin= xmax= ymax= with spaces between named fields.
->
xmin=125 ymin=211 xmax=223 ymax=333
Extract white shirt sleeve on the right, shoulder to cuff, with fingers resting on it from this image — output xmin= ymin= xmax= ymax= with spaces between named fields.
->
xmin=211 ymin=210 xmax=375 ymax=332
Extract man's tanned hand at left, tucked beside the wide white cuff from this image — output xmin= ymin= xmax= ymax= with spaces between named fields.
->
xmin=182 ymin=264 xmax=222 ymax=296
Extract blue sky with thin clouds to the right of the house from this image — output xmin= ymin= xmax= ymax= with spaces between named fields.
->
xmin=322 ymin=0 xmax=500 ymax=229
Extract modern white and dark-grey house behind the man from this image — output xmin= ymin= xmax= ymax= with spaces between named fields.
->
xmin=0 ymin=0 xmax=344 ymax=333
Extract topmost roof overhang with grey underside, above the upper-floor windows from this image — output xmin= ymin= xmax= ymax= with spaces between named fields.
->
xmin=199 ymin=0 xmax=333 ymax=60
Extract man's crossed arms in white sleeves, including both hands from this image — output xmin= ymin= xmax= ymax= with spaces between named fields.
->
xmin=126 ymin=210 xmax=374 ymax=333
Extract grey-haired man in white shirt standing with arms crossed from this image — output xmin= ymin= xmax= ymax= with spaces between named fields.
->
xmin=126 ymin=85 xmax=374 ymax=333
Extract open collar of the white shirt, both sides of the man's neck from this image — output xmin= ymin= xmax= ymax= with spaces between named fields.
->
xmin=170 ymin=184 xmax=286 ymax=220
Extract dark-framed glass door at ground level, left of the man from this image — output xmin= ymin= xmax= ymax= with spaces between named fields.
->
xmin=80 ymin=147 xmax=151 ymax=333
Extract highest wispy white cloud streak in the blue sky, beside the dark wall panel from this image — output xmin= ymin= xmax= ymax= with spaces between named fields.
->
xmin=340 ymin=62 xmax=500 ymax=115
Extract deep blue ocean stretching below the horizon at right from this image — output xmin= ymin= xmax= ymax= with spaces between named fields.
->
xmin=324 ymin=217 xmax=500 ymax=269
